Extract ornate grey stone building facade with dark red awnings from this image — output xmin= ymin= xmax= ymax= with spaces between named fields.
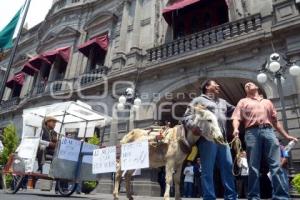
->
xmin=0 ymin=0 xmax=300 ymax=195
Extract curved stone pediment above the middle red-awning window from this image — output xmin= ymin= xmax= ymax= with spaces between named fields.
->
xmin=84 ymin=11 xmax=118 ymax=31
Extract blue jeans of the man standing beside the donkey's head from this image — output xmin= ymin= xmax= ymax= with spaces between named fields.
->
xmin=198 ymin=138 xmax=237 ymax=200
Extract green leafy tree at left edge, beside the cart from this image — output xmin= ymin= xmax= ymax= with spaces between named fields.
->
xmin=0 ymin=124 xmax=19 ymax=165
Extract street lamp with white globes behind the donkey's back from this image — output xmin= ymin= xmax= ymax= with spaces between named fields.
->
xmin=117 ymin=88 xmax=142 ymax=132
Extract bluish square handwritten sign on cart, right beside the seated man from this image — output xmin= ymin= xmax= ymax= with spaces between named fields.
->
xmin=58 ymin=137 xmax=81 ymax=162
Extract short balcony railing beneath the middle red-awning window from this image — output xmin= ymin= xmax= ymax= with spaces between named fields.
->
xmin=80 ymin=66 xmax=108 ymax=86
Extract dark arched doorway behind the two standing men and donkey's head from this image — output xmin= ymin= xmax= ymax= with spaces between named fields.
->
xmin=158 ymin=77 xmax=266 ymax=198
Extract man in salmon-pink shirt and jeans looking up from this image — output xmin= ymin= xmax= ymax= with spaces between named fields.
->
xmin=232 ymin=82 xmax=298 ymax=200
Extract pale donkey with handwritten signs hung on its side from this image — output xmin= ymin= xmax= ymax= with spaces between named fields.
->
xmin=113 ymin=106 xmax=225 ymax=200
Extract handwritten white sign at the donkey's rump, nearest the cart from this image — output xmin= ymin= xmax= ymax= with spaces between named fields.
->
xmin=93 ymin=146 xmax=117 ymax=174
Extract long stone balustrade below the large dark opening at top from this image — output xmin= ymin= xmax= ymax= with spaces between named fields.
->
xmin=147 ymin=14 xmax=262 ymax=62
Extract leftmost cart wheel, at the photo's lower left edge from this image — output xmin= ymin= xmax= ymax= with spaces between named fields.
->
xmin=2 ymin=172 xmax=25 ymax=194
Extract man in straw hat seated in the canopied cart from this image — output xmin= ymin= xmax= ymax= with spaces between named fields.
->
xmin=37 ymin=116 xmax=57 ymax=173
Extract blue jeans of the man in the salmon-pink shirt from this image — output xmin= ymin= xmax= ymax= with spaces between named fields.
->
xmin=245 ymin=128 xmax=289 ymax=200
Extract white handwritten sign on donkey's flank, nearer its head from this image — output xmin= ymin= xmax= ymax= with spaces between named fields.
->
xmin=121 ymin=140 xmax=149 ymax=170
